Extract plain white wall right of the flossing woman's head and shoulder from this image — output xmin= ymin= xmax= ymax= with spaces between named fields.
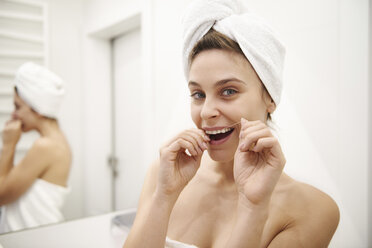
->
xmin=277 ymin=1 xmax=368 ymax=247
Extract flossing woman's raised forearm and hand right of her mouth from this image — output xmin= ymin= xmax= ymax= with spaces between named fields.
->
xmin=226 ymin=118 xmax=285 ymax=248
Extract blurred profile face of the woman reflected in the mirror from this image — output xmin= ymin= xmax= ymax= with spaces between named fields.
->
xmin=12 ymin=93 xmax=38 ymax=132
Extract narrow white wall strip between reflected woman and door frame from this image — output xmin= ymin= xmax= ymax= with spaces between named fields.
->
xmin=42 ymin=0 xmax=84 ymax=219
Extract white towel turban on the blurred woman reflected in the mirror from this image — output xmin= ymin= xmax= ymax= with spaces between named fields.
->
xmin=14 ymin=62 xmax=65 ymax=118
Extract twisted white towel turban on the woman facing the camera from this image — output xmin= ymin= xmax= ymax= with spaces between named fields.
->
xmin=182 ymin=0 xmax=285 ymax=105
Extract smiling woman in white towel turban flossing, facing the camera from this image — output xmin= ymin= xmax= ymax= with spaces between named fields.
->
xmin=124 ymin=0 xmax=339 ymax=248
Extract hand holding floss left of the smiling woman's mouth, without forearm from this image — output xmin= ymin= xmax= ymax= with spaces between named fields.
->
xmin=157 ymin=128 xmax=210 ymax=199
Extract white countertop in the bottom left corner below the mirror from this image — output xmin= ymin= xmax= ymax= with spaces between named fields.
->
xmin=0 ymin=209 xmax=133 ymax=248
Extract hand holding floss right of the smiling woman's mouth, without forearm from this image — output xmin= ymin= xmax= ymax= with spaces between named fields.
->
xmin=234 ymin=118 xmax=286 ymax=206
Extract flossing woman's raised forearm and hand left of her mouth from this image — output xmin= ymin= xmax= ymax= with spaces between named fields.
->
xmin=124 ymin=129 xmax=208 ymax=248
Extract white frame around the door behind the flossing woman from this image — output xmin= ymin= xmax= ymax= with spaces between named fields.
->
xmin=83 ymin=1 xmax=155 ymax=215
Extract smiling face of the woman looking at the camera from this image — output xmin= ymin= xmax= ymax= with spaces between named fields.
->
xmin=188 ymin=49 xmax=275 ymax=162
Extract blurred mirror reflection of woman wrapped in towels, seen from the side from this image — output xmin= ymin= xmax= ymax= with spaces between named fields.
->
xmin=0 ymin=62 xmax=71 ymax=232
